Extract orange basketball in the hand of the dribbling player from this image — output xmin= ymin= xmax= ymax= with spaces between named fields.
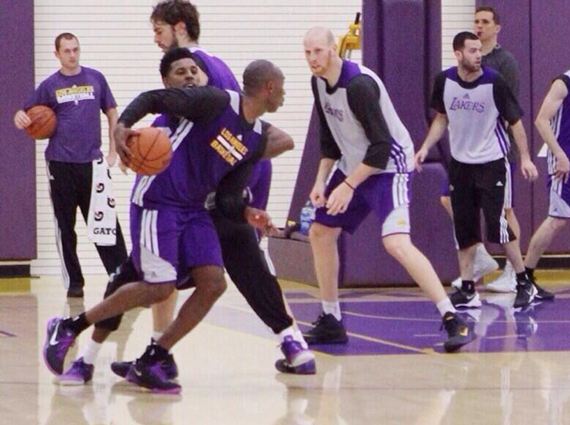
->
xmin=127 ymin=127 xmax=172 ymax=175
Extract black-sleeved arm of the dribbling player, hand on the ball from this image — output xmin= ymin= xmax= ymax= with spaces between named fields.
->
xmin=114 ymin=87 xmax=230 ymax=166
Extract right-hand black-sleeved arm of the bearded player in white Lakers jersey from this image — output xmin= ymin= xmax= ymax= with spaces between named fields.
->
xmin=493 ymin=75 xmax=538 ymax=181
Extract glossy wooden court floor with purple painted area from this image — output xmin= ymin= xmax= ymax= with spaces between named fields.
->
xmin=0 ymin=274 xmax=570 ymax=425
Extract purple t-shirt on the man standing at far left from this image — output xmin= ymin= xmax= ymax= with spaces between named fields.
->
xmin=24 ymin=66 xmax=117 ymax=163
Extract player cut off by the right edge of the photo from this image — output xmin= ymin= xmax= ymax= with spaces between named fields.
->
xmin=525 ymin=71 xmax=570 ymax=294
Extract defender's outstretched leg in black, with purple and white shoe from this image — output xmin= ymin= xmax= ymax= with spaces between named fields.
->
xmin=212 ymin=212 xmax=315 ymax=374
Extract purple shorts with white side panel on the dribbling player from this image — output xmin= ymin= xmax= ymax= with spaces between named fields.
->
xmin=131 ymin=204 xmax=223 ymax=283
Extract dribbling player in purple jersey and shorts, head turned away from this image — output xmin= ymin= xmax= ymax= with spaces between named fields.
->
xmin=43 ymin=55 xmax=285 ymax=393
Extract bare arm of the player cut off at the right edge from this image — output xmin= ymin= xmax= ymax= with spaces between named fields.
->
xmin=534 ymin=76 xmax=570 ymax=181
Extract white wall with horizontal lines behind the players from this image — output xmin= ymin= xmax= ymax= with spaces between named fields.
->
xmin=32 ymin=0 xmax=475 ymax=275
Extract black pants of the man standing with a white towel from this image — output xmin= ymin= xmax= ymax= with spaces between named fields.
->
xmin=48 ymin=161 xmax=127 ymax=288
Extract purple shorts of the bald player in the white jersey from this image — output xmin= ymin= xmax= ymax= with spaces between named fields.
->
xmin=315 ymin=170 xmax=411 ymax=236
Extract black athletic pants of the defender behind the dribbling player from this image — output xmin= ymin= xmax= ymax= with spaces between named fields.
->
xmin=95 ymin=207 xmax=293 ymax=334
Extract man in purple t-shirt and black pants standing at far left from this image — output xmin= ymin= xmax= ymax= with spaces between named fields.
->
xmin=14 ymin=33 xmax=127 ymax=298
